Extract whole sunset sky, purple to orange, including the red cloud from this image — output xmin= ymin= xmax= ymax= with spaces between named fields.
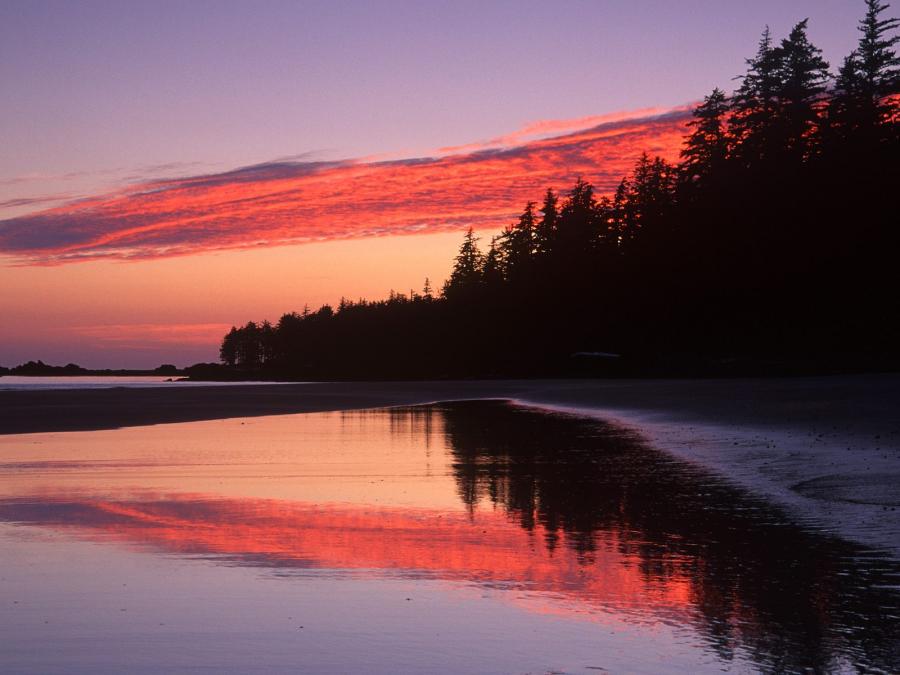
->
xmin=0 ymin=0 xmax=880 ymax=367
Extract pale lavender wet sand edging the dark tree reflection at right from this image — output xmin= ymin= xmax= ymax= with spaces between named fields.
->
xmin=513 ymin=399 xmax=900 ymax=560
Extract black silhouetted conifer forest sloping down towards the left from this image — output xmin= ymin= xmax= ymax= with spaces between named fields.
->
xmin=218 ymin=0 xmax=900 ymax=379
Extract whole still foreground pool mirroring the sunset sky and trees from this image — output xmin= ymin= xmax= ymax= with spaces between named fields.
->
xmin=0 ymin=401 xmax=900 ymax=673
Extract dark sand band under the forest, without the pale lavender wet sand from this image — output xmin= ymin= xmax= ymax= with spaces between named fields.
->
xmin=0 ymin=375 xmax=900 ymax=442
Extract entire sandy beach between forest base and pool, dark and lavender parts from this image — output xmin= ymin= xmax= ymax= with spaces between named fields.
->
xmin=0 ymin=375 xmax=900 ymax=555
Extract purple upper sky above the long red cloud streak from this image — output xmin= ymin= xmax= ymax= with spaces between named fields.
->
xmin=0 ymin=0 xmax=863 ymax=217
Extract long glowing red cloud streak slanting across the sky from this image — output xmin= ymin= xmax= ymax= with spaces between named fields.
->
xmin=0 ymin=108 xmax=689 ymax=265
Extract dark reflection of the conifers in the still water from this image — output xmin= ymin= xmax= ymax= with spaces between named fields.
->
xmin=437 ymin=402 xmax=900 ymax=672
